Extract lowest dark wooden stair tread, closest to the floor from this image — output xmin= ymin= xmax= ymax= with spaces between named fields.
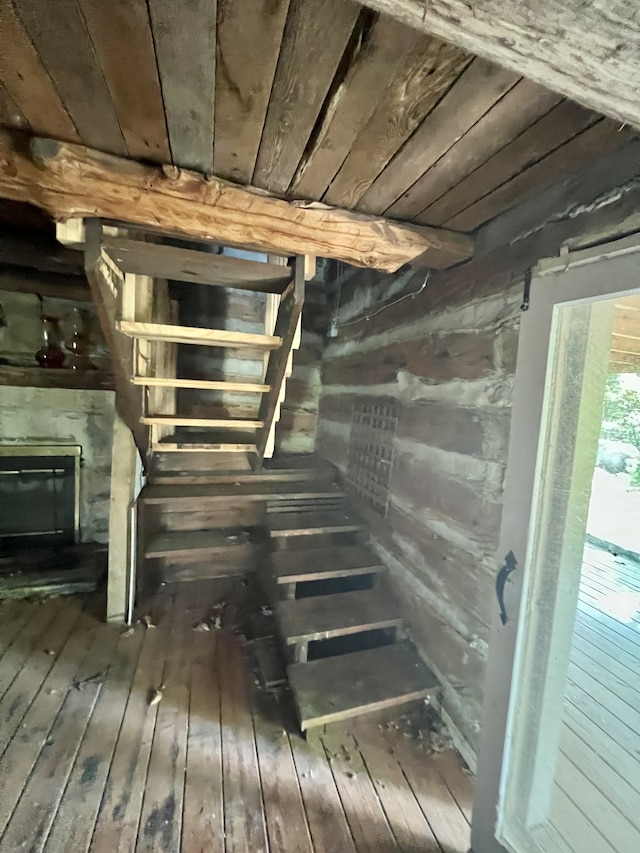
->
xmin=287 ymin=643 xmax=438 ymax=731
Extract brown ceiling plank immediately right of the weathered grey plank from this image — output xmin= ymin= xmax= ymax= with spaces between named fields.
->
xmin=213 ymin=0 xmax=289 ymax=184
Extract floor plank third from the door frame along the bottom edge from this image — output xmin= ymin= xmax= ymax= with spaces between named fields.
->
xmin=322 ymin=733 xmax=398 ymax=853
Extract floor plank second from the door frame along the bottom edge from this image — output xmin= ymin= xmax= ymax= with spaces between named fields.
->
xmin=354 ymin=724 xmax=440 ymax=853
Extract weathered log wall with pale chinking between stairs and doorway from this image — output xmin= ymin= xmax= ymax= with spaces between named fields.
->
xmin=316 ymin=176 xmax=640 ymax=750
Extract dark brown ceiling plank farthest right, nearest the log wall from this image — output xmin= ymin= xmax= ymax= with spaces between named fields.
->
xmin=446 ymin=118 xmax=632 ymax=232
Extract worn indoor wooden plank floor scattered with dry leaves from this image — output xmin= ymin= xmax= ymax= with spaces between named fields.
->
xmin=0 ymin=582 xmax=472 ymax=853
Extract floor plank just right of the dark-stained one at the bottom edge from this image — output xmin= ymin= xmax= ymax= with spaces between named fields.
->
xmin=182 ymin=632 xmax=225 ymax=853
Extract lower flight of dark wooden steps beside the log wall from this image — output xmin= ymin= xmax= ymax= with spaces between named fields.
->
xmin=267 ymin=496 xmax=438 ymax=731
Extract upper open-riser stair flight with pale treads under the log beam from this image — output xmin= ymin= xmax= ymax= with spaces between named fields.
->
xmin=75 ymin=221 xmax=305 ymax=469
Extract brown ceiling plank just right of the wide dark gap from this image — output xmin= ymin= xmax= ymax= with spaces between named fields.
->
xmin=290 ymin=16 xmax=431 ymax=199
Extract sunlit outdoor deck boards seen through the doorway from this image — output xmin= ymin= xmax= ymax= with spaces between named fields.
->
xmin=554 ymin=545 xmax=640 ymax=853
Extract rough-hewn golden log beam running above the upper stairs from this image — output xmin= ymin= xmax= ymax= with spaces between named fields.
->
xmin=0 ymin=132 xmax=473 ymax=272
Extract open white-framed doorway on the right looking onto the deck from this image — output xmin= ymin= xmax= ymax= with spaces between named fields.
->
xmin=473 ymin=240 xmax=640 ymax=853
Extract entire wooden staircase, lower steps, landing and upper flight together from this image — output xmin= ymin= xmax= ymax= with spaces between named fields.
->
xmin=58 ymin=220 xmax=437 ymax=730
